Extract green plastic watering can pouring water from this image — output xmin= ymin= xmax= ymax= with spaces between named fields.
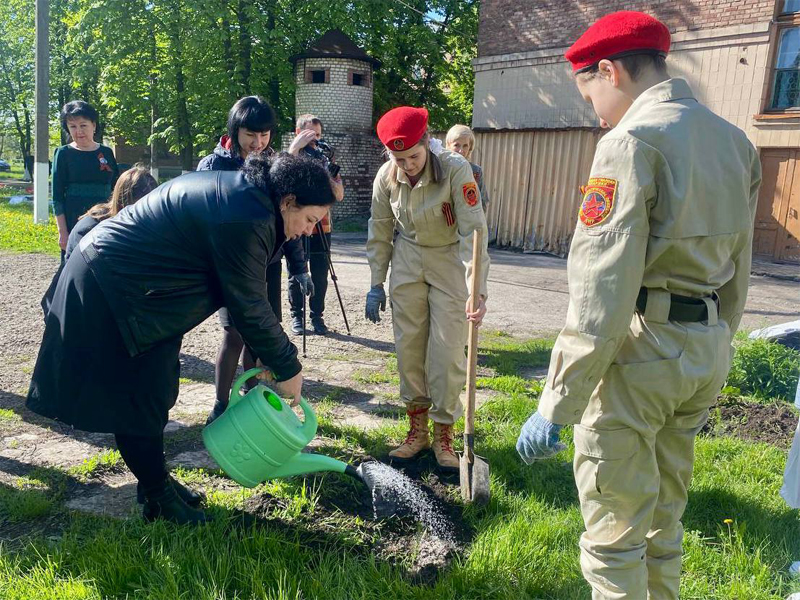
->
xmin=203 ymin=369 xmax=358 ymax=488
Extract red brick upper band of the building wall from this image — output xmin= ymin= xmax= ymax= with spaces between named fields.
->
xmin=478 ymin=0 xmax=776 ymax=57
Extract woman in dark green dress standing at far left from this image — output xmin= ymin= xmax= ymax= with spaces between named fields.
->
xmin=53 ymin=100 xmax=119 ymax=262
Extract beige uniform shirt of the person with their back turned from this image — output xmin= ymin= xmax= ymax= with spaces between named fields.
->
xmin=539 ymin=79 xmax=761 ymax=424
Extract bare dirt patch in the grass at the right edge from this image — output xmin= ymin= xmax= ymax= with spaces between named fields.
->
xmin=702 ymin=399 xmax=797 ymax=449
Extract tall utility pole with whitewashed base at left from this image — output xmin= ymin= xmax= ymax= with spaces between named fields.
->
xmin=33 ymin=0 xmax=50 ymax=223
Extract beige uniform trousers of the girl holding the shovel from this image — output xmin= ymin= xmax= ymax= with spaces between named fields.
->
xmin=389 ymin=236 xmax=467 ymax=424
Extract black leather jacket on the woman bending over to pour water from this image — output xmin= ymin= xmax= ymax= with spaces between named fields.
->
xmin=80 ymin=171 xmax=301 ymax=380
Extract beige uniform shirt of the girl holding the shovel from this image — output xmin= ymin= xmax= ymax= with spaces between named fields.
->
xmin=367 ymin=150 xmax=489 ymax=296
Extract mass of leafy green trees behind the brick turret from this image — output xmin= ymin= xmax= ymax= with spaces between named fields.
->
xmin=0 ymin=0 xmax=478 ymax=164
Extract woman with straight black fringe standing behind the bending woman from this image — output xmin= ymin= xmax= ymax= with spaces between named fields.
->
xmin=197 ymin=96 xmax=313 ymax=425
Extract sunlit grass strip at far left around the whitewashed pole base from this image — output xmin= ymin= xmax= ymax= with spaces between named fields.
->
xmin=0 ymin=187 xmax=59 ymax=256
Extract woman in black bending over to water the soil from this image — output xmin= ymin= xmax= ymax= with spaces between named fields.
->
xmin=27 ymin=154 xmax=335 ymax=523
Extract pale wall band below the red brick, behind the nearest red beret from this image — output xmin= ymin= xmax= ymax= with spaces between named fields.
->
xmin=472 ymin=20 xmax=776 ymax=145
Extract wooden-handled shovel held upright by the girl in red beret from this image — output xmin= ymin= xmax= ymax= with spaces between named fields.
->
xmin=459 ymin=229 xmax=489 ymax=505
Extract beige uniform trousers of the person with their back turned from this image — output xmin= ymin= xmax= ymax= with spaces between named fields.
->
xmin=574 ymin=290 xmax=731 ymax=600
